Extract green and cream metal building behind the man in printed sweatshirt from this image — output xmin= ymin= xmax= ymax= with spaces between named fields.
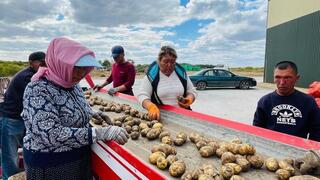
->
xmin=264 ymin=0 xmax=320 ymax=87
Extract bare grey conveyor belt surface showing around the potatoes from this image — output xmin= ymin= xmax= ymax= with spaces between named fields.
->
xmin=94 ymin=93 xmax=306 ymax=180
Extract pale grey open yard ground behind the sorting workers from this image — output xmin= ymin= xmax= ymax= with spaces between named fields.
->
xmin=81 ymin=77 xmax=274 ymax=124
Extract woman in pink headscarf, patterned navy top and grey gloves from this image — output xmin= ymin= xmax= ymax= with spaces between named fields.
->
xmin=21 ymin=38 xmax=127 ymax=180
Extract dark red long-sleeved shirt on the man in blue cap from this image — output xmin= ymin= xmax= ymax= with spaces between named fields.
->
xmin=107 ymin=62 xmax=136 ymax=95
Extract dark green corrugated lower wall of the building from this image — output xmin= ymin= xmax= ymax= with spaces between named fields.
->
xmin=264 ymin=11 xmax=320 ymax=87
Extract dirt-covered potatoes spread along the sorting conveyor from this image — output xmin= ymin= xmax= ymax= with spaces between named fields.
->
xmin=85 ymin=91 xmax=310 ymax=180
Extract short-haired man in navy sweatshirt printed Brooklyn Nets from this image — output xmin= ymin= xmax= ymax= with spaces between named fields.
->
xmin=253 ymin=61 xmax=320 ymax=141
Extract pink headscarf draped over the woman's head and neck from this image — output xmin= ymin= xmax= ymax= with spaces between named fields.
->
xmin=31 ymin=37 xmax=95 ymax=88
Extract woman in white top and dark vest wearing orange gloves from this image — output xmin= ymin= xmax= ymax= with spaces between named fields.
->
xmin=137 ymin=46 xmax=197 ymax=120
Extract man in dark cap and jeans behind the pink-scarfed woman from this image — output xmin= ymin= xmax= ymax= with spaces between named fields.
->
xmin=0 ymin=51 xmax=45 ymax=180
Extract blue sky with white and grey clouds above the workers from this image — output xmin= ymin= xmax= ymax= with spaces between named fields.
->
xmin=0 ymin=0 xmax=267 ymax=67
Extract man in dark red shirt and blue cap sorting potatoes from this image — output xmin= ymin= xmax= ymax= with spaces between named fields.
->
xmin=93 ymin=46 xmax=136 ymax=96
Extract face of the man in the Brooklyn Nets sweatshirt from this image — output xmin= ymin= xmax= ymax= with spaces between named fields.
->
xmin=273 ymin=67 xmax=300 ymax=96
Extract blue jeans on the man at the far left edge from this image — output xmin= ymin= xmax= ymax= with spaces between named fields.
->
xmin=0 ymin=117 xmax=25 ymax=180
